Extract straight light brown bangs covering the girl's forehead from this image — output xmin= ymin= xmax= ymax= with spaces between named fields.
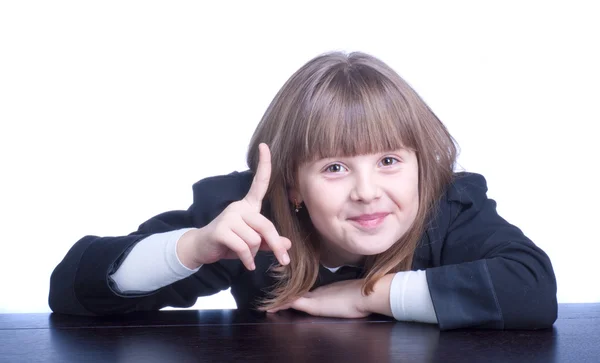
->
xmin=297 ymin=70 xmax=415 ymax=163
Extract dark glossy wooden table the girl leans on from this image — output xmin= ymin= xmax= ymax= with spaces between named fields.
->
xmin=0 ymin=304 xmax=600 ymax=363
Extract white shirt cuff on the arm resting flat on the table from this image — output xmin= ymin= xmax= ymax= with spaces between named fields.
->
xmin=390 ymin=270 xmax=438 ymax=324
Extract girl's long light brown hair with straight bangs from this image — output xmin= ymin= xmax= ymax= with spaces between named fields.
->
xmin=247 ymin=52 xmax=457 ymax=308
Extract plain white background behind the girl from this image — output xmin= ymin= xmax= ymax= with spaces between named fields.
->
xmin=0 ymin=0 xmax=600 ymax=312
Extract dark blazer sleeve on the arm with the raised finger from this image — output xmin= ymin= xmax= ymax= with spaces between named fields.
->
xmin=48 ymin=172 xmax=249 ymax=315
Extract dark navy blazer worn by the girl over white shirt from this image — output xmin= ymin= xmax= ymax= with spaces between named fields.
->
xmin=49 ymin=171 xmax=557 ymax=330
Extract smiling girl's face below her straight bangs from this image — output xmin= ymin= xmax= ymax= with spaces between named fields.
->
xmin=290 ymin=149 xmax=419 ymax=267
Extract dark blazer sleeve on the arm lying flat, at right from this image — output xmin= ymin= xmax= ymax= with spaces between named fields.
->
xmin=426 ymin=173 xmax=557 ymax=330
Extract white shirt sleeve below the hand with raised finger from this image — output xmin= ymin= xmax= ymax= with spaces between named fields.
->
xmin=110 ymin=228 xmax=200 ymax=293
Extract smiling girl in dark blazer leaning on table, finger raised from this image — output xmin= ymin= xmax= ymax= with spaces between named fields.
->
xmin=49 ymin=53 xmax=557 ymax=330
